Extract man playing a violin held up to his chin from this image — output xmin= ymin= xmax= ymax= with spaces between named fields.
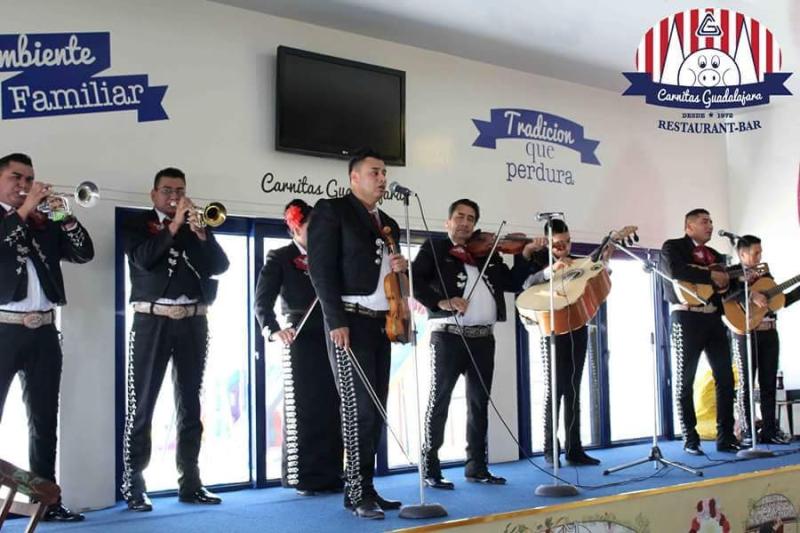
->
xmin=412 ymin=198 xmax=543 ymax=489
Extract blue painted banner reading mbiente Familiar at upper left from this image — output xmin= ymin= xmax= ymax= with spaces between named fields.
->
xmin=0 ymin=32 xmax=169 ymax=122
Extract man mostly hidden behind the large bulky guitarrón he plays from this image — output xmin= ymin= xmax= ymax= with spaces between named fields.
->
xmin=523 ymin=219 xmax=612 ymax=466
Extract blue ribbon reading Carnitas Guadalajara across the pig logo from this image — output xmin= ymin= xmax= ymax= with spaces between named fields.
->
xmin=622 ymin=72 xmax=792 ymax=109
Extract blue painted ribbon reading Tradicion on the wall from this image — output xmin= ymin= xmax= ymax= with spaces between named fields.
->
xmin=472 ymin=108 xmax=600 ymax=165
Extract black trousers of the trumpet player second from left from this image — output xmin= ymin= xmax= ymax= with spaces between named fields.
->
xmin=122 ymin=313 xmax=208 ymax=498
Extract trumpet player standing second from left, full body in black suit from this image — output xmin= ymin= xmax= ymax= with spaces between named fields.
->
xmin=121 ymin=168 xmax=229 ymax=512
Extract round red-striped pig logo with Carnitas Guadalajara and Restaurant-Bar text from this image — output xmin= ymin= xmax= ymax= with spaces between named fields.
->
xmin=623 ymin=8 xmax=791 ymax=134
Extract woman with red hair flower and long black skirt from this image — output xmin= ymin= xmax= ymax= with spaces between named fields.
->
xmin=255 ymin=199 xmax=343 ymax=496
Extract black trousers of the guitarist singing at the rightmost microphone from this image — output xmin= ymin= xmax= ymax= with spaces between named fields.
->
xmin=670 ymin=311 xmax=736 ymax=444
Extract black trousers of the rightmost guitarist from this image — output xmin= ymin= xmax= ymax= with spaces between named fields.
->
xmin=733 ymin=329 xmax=780 ymax=437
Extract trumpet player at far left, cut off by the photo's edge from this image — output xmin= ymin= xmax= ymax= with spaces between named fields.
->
xmin=0 ymin=154 xmax=94 ymax=522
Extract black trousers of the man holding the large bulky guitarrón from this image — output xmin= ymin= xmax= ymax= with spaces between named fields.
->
xmin=541 ymin=326 xmax=589 ymax=455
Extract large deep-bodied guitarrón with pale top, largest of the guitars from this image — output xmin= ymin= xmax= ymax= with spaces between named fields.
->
xmin=516 ymin=226 xmax=638 ymax=335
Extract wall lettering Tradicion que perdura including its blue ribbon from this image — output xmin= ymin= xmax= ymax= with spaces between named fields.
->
xmin=472 ymin=108 xmax=600 ymax=186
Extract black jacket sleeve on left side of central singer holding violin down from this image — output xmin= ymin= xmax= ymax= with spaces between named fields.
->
xmin=308 ymin=200 xmax=348 ymax=329
